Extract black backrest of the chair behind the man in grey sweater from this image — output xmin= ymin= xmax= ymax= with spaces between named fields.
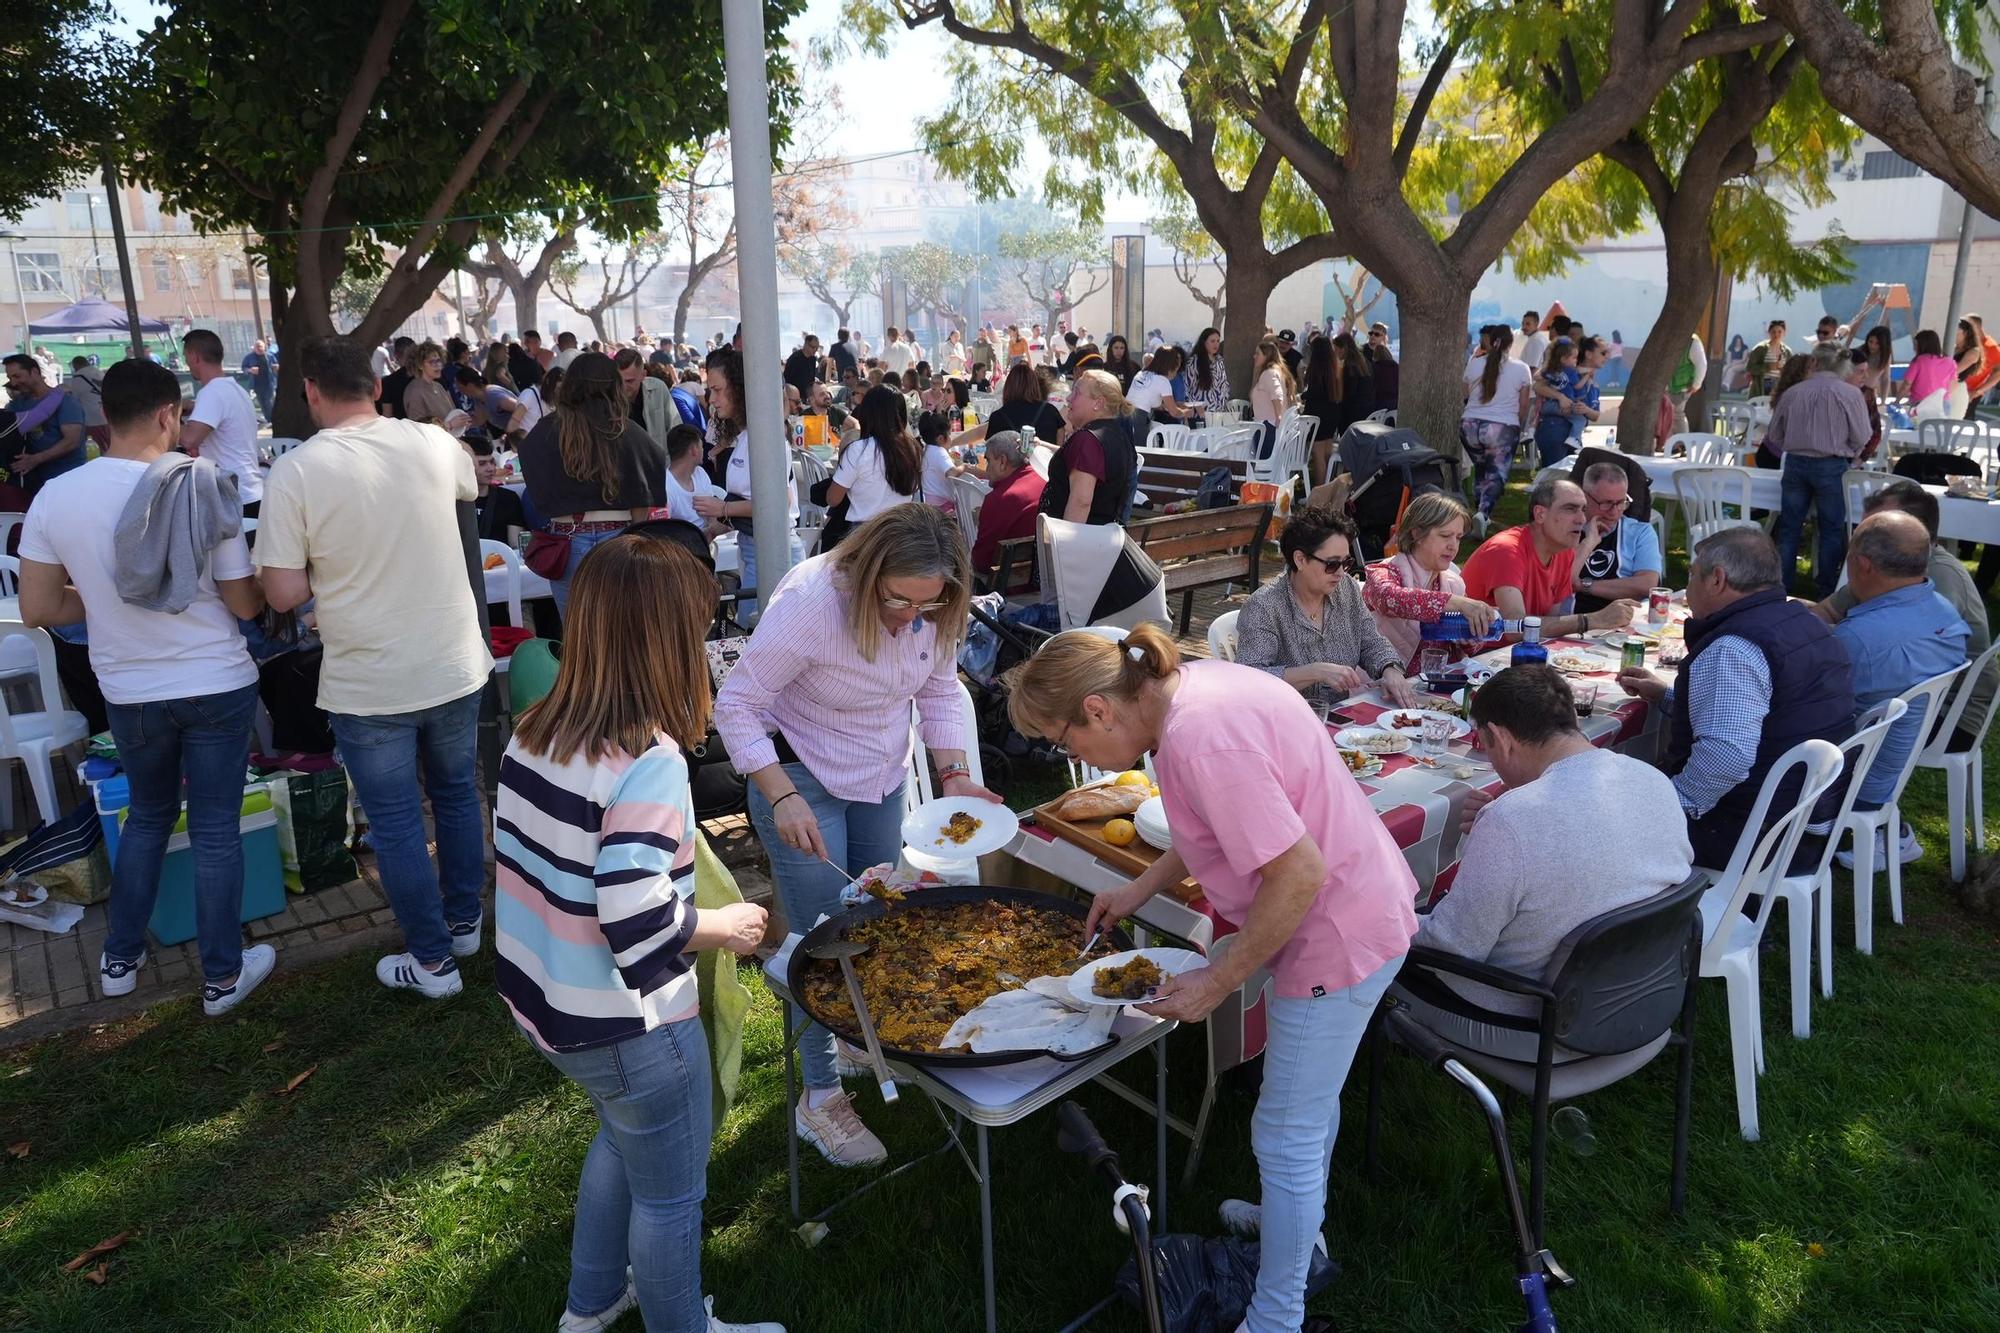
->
xmin=1542 ymin=871 xmax=1708 ymax=1055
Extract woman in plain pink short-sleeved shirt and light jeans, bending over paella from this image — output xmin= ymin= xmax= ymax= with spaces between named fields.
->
xmin=1008 ymin=624 xmax=1416 ymax=1333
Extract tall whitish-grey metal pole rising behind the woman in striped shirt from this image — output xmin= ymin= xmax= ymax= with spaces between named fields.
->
xmin=722 ymin=0 xmax=792 ymax=592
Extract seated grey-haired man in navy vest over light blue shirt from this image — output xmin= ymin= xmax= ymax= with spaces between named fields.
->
xmin=1618 ymin=528 xmax=1854 ymax=869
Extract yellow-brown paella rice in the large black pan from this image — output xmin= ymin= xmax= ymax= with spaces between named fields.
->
xmin=804 ymin=901 xmax=1116 ymax=1051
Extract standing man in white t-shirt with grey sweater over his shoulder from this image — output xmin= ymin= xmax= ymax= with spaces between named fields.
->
xmin=20 ymin=360 xmax=278 ymax=1015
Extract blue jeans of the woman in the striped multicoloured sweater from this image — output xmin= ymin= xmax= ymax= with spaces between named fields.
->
xmin=542 ymin=1019 xmax=714 ymax=1333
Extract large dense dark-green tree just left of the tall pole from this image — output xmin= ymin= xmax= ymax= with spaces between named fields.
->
xmin=126 ymin=0 xmax=800 ymax=434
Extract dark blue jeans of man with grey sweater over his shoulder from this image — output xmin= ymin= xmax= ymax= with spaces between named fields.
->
xmin=104 ymin=685 xmax=256 ymax=981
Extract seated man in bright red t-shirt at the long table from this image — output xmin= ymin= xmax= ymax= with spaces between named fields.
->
xmin=1464 ymin=478 xmax=1638 ymax=638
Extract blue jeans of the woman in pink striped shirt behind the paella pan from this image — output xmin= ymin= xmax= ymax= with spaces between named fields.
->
xmin=750 ymin=765 xmax=904 ymax=1089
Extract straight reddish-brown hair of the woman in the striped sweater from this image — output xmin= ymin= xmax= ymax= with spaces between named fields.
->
xmin=514 ymin=528 xmax=716 ymax=765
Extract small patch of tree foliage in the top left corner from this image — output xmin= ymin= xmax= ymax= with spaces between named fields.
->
xmin=0 ymin=0 xmax=132 ymax=218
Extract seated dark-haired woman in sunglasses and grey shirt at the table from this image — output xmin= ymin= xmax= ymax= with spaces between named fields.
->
xmin=1236 ymin=506 xmax=1416 ymax=709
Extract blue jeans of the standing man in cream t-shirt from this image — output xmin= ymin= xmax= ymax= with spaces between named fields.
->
xmin=330 ymin=691 xmax=486 ymax=965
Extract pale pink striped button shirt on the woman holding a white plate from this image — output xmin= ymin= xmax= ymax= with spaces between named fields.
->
xmin=716 ymin=554 xmax=966 ymax=801
